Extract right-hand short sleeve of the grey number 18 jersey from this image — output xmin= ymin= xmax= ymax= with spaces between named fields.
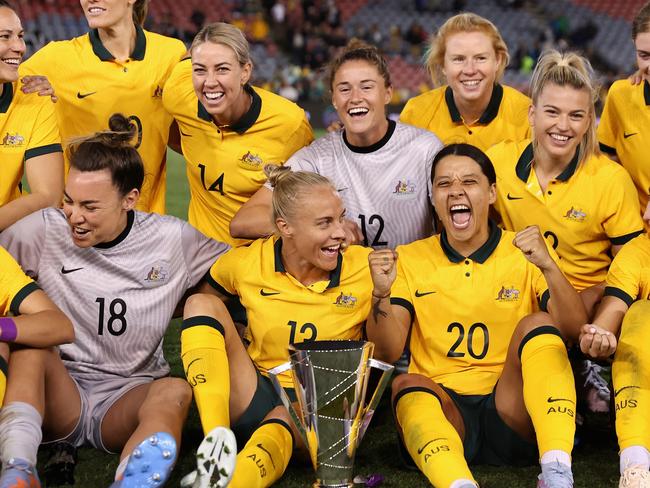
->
xmin=181 ymin=222 xmax=230 ymax=286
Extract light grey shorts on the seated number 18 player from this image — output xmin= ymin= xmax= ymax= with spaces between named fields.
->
xmin=43 ymin=373 xmax=153 ymax=454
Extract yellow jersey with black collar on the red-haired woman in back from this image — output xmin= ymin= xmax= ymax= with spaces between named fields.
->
xmin=400 ymin=84 xmax=530 ymax=151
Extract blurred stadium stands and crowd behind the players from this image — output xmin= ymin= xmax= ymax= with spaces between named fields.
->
xmin=16 ymin=0 xmax=645 ymax=128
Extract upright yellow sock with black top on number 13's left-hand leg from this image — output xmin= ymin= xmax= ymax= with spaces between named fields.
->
xmin=181 ymin=316 xmax=230 ymax=434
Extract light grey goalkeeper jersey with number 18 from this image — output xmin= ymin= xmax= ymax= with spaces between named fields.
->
xmin=0 ymin=208 xmax=229 ymax=380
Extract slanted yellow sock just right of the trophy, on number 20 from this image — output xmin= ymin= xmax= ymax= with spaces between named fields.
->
xmin=395 ymin=388 xmax=474 ymax=488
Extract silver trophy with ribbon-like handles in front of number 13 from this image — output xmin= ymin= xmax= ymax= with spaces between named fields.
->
xmin=268 ymin=341 xmax=393 ymax=488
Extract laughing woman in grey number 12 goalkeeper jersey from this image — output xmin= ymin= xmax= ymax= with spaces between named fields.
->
xmin=230 ymin=40 xmax=441 ymax=249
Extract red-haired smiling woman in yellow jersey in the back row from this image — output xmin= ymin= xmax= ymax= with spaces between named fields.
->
xmin=400 ymin=13 xmax=530 ymax=151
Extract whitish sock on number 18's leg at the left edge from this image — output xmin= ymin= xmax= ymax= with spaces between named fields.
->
xmin=0 ymin=402 xmax=43 ymax=466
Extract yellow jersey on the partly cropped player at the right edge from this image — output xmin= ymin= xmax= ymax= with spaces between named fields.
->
xmin=598 ymin=80 xmax=650 ymax=212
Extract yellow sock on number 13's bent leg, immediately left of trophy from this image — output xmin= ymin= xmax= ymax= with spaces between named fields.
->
xmin=228 ymin=419 xmax=293 ymax=488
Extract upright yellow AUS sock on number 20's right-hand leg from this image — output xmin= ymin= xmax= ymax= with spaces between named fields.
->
xmin=519 ymin=325 xmax=576 ymax=455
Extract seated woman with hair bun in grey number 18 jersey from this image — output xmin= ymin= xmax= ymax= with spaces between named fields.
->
xmin=0 ymin=115 xmax=227 ymax=487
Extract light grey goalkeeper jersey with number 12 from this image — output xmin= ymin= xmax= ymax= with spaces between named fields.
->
xmin=270 ymin=121 xmax=442 ymax=249
